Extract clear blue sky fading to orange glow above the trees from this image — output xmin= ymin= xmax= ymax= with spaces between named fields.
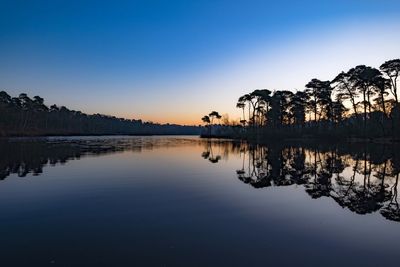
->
xmin=0 ymin=0 xmax=400 ymax=125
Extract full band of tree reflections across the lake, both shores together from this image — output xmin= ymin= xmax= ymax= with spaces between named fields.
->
xmin=0 ymin=137 xmax=400 ymax=221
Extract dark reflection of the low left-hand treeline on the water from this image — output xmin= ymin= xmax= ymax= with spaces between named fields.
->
xmin=0 ymin=137 xmax=199 ymax=180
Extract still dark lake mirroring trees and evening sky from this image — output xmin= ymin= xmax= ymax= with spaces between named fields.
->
xmin=0 ymin=137 xmax=400 ymax=266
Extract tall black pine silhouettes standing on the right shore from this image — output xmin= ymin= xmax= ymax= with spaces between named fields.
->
xmin=202 ymin=59 xmax=400 ymax=139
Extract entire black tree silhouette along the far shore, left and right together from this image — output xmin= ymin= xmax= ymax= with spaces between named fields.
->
xmin=0 ymin=59 xmax=400 ymax=140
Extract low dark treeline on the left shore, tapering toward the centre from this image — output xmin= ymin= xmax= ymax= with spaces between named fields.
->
xmin=0 ymin=91 xmax=200 ymax=136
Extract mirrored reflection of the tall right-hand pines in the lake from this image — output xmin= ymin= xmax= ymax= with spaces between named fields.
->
xmin=202 ymin=142 xmax=400 ymax=224
